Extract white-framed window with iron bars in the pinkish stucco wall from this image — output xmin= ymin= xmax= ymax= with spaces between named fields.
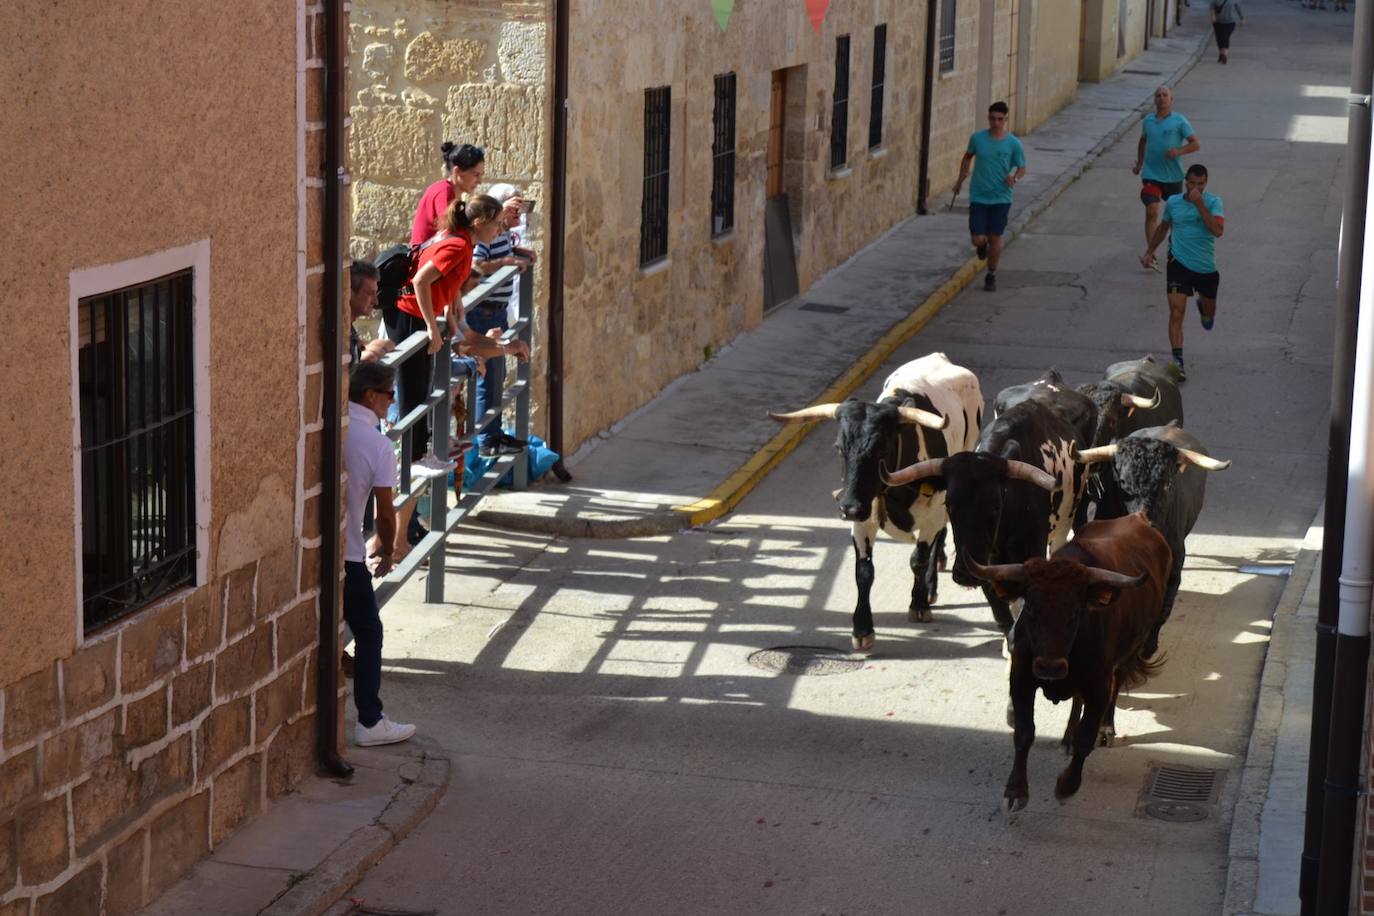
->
xmin=77 ymin=271 xmax=196 ymax=633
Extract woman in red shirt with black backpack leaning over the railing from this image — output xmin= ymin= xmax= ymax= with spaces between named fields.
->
xmin=398 ymin=195 xmax=529 ymax=466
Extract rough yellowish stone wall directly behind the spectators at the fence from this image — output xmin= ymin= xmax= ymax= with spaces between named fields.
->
xmin=349 ymin=0 xmax=551 ymax=428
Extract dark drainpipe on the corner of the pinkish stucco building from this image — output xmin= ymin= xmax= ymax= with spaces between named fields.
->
xmin=315 ymin=0 xmax=353 ymax=776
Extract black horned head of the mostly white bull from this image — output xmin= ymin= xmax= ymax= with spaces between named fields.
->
xmin=768 ymin=398 xmax=949 ymax=522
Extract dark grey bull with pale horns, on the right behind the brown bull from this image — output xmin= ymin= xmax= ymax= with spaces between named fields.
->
xmin=1077 ymin=424 xmax=1231 ymax=656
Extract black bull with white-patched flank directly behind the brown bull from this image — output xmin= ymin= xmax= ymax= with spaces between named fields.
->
xmin=886 ymin=391 xmax=1092 ymax=632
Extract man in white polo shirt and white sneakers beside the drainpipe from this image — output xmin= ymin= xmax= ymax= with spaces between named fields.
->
xmin=344 ymin=363 xmax=415 ymax=747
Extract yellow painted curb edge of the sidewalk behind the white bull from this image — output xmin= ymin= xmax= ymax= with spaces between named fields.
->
xmin=673 ymin=258 xmax=982 ymax=527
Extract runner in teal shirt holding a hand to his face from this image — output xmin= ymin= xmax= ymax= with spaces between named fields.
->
xmin=1140 ymin=163 xmax=1226 ymax=382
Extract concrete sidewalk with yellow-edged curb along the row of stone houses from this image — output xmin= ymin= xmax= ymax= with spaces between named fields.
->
xmin=475 ymin=16 xmax=1210 ymax=537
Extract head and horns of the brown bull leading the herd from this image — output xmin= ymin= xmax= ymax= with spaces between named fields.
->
xmin=970 ymin=559 xmax=1146 ymax=681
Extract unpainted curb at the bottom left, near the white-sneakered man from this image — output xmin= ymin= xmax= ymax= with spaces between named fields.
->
xmin=258 ymin=754 xmax=449 ymax=916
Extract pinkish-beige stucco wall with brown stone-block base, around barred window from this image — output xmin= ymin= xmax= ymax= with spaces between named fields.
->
xmin=0 ymin=0 xmax=323 ymax=913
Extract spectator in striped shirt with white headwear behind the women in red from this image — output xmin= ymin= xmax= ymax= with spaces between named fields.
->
xmin=467 ymin=184 xmax=534 ymax=457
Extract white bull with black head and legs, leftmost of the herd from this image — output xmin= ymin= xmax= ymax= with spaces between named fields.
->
xmin=768 ymin=353 xmax=982 ymax=651
